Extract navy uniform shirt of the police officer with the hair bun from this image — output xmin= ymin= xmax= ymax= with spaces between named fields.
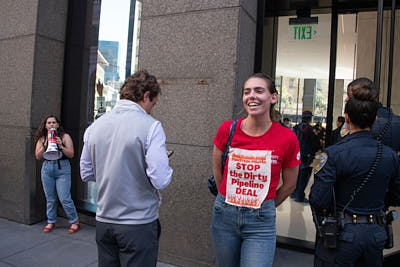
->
xmin=310 ymin=131 xmax=400 ymax=214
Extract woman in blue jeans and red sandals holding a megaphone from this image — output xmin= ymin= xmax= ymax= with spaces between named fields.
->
xmin=35 ymin=115 xmax=80 ymax=234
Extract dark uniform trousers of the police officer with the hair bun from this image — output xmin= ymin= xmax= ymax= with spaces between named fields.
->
xmin=314 ymin=224 xmax=387 ymax=267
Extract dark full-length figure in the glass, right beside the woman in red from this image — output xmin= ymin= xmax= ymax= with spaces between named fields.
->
xmin=291 ymin=110 xmax=320 ymax=203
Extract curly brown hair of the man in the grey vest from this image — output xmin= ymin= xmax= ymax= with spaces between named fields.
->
xmin=119 ymin=70 xmax=161 ymax=102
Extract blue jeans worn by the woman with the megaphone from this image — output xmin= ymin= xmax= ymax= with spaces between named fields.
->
xmin=42 ymin=159 xmax=78 ymax=223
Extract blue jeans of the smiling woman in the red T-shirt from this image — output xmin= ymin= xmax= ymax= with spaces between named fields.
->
xmin=211 ymin=194 xmax=276 ymax=267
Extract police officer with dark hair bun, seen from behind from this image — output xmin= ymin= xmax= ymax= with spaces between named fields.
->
xmin=310 ymin=80 xmax=400 ymax=266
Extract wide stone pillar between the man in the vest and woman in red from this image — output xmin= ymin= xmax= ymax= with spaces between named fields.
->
xmin=139 ymin=0 xmax=257 ymax=266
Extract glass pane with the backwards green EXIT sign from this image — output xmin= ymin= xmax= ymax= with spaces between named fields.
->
xmin=275 ymin=14 xmax=331 ymax=245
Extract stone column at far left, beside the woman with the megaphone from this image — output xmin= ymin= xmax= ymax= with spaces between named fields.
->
xmin=0 ymin=0 xmax=68 ymax=223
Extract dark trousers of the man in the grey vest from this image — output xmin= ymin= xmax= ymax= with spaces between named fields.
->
xmin=96 ymin=220 xmax=158 ymax=267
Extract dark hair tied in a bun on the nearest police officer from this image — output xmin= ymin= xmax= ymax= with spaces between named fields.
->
xmin=344 ymin=81 xmax=379 ymax=129
